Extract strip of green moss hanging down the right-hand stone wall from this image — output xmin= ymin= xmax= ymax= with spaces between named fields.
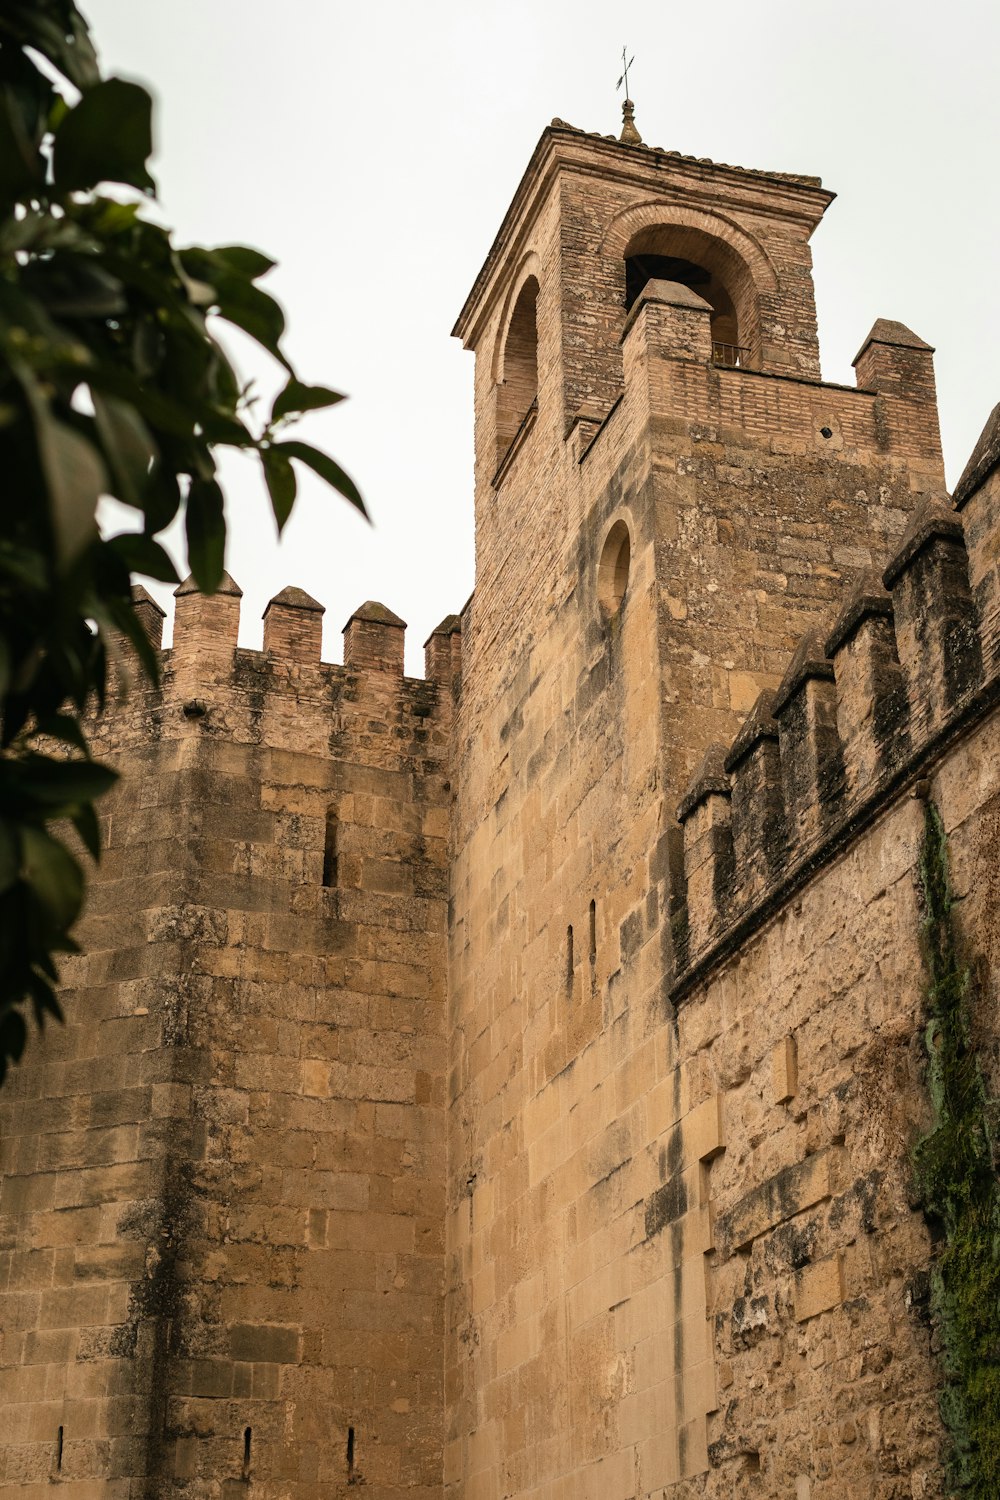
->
xmin=915 ymin=803 xmax=1000 ymax=1500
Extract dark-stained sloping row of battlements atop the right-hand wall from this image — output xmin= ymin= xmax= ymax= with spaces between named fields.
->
xmin=673 ymin=411 xmax=1000 ymax=998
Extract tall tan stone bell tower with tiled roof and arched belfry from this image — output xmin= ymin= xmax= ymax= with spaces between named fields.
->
xmin=445 ymin=120 xmax=945 ymax=1500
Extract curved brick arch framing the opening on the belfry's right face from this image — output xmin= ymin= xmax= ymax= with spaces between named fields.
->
xmin=600 ymin=200 xmax=778 ymax=363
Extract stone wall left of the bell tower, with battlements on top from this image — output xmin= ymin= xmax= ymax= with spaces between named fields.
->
xmin=0 ymin=582 xmax=454 ymax=1500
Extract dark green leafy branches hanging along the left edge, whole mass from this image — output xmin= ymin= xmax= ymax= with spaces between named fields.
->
xmin=0 ymin=0 xmax=363 ymax=1080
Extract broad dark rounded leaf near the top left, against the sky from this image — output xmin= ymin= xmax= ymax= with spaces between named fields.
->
xmin=52 ymin=78 xmax=154 ymax=192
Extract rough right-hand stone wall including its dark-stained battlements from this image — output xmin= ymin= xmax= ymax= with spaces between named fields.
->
xmin=663 ymin=462 xmax=1000 ymax=1500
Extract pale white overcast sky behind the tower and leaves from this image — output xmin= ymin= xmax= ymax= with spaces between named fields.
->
xmin=81 ymin=0 xmax=1000 ymax=675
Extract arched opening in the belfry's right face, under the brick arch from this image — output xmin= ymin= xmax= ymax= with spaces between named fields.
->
xmin=625 ymin=225 xmax=760 ymax=369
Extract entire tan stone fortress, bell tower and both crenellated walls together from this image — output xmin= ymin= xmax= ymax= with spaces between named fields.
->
xmin=0 ymin=108 xmax=1000 ymax=1500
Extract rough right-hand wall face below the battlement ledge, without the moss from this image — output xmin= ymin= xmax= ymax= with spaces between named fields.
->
xmin=659 ymin=711 xmax=1000 ymax=1500
